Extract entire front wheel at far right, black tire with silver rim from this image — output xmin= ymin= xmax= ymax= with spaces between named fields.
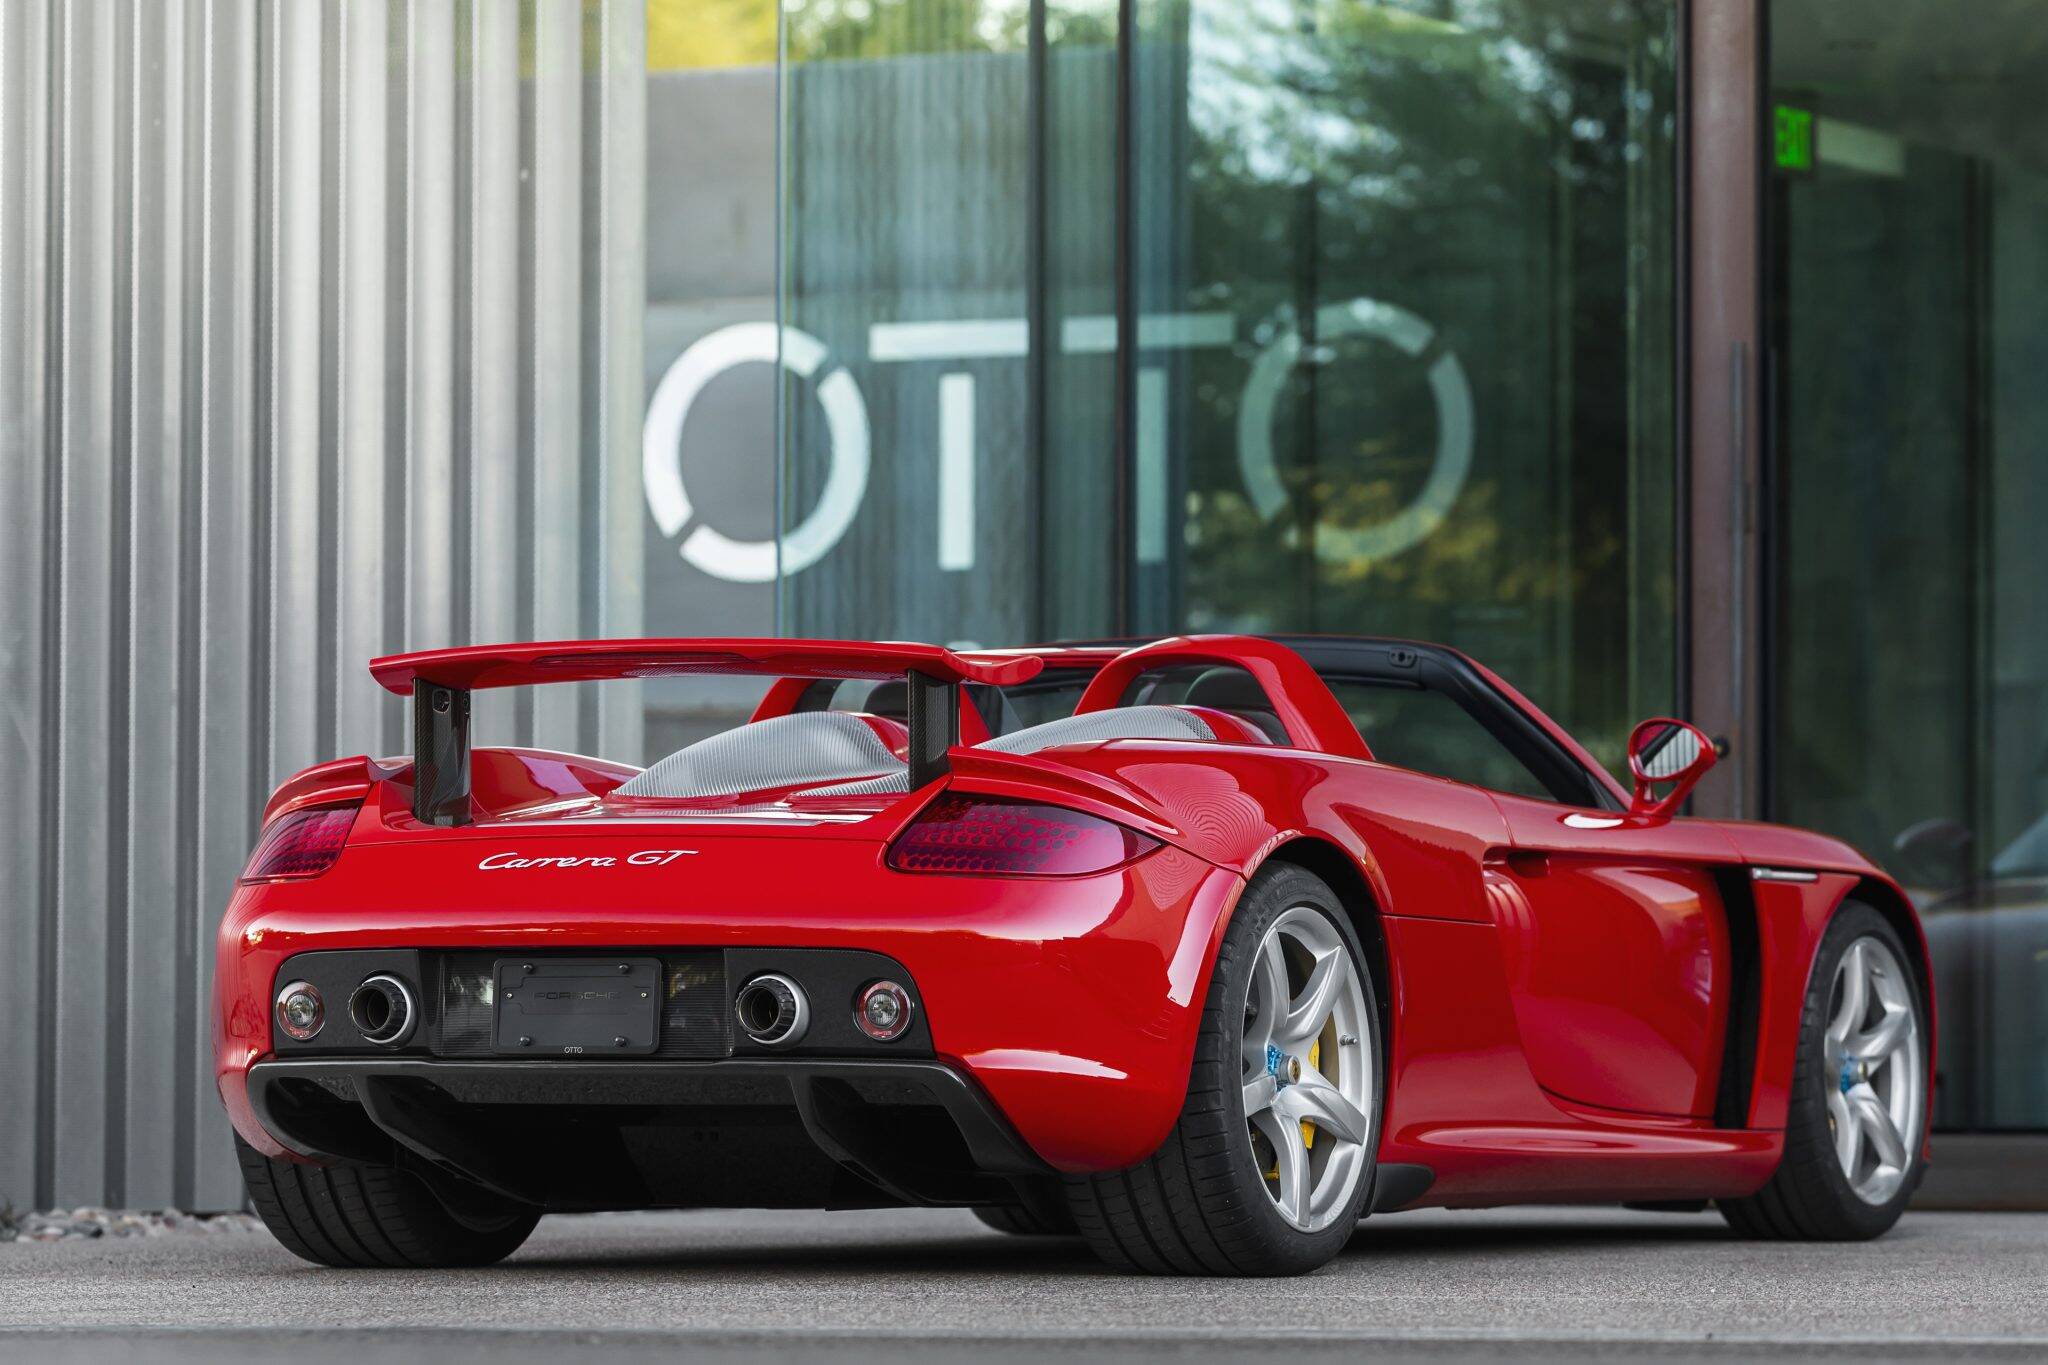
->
xmin=1720 ymin=900 xmax=1927 ymax=1242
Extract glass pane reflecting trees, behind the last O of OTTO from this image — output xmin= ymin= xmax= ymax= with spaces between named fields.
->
xmin=1130 ymin=0 xmax=1675 ymax=759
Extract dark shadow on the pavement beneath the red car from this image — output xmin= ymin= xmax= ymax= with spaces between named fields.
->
xmin=491 ymin=1212 xmax=1733 ymax=1277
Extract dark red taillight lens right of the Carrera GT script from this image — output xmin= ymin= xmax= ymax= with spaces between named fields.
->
xmin=889 ymin=796 xmax=1159 ymax=876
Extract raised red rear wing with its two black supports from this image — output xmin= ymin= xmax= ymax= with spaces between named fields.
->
xmin=371 ymin=639 xmax=1044 ymax=825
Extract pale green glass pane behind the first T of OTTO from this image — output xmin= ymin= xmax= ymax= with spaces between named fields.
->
xmin=780 ymin=0 xmax=1120 ymax=643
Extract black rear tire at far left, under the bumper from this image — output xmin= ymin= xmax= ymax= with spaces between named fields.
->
xmin=236 ymin=1136 xmax=541 ymax=1269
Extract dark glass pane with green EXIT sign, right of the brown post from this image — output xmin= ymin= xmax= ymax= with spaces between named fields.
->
xmin=1765 ymin=0 xmax=2048 ymax=1130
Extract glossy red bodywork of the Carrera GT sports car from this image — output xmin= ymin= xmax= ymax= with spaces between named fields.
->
xmin=215 ymin=636 xmax=1925 ymax=1205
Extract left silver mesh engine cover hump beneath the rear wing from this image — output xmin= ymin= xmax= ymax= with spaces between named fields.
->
xmin=614 ymin=710 xmax=903 ymax=798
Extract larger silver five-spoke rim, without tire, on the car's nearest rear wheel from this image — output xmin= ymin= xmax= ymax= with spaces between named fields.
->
xmin=1243 ymin=905 xmax=1378 ymax=1232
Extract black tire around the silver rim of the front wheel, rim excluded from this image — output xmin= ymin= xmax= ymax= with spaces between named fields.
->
xmin=1716 ymin=900 xmax=1931 ymax=1242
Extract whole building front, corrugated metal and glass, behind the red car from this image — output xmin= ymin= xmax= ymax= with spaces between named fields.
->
xmin=0 ymin=0 xmax=2048 ymax=1207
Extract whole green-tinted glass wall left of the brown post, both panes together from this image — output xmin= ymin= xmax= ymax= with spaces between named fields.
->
xmin=780 ymin=0 xmax=1677 ymax=757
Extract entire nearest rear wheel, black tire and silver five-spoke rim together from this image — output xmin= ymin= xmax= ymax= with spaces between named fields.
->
xmin=1067 ymin=864 xmax=1380 ymax=1275
